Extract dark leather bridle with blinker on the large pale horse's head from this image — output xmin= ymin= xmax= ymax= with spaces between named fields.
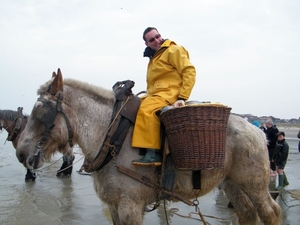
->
xmin=26 ymin=90 xmax=73 ymax=169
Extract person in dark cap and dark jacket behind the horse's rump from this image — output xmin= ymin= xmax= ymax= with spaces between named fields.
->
xmin=272 ymin=131 xmax=289 ymax=190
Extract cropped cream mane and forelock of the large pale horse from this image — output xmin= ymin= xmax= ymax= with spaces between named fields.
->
xmin=37 ymin=78 xmax=115 ymax=100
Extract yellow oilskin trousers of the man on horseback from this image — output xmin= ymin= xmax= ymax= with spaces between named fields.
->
xmin=132 ymin=96 xmax=170 ymax=149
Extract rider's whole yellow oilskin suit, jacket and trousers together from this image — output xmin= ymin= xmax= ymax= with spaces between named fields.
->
xmin=132 ymin=40 xmax=196 ymax=149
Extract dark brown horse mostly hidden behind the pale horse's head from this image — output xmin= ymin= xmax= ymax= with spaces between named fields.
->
xmin=0 ymin=107 xmax=75 ymax=181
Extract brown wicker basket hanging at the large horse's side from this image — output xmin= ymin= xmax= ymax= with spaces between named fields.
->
xmin=160 ymin=104 xmax=231 ymax=170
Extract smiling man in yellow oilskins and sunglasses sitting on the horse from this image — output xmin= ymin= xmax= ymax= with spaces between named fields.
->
xmin=132 ymin=27 xmax=196 ymax=166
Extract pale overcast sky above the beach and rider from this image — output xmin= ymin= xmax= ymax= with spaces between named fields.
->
xmin=0 ymin=0 xmax=300 ymax=119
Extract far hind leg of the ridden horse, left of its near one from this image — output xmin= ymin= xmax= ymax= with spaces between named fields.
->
xmin=223 ymin=177 xmax=259 ymax=225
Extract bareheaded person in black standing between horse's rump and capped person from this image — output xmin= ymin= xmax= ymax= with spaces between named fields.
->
xmin=265 ymin=119 xmax=278 ymax=176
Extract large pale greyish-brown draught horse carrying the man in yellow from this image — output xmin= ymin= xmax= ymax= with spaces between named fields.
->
xmin=17 ymin=70 xmax=281 ymax=225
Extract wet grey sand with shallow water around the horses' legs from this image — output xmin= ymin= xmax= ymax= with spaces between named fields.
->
xmin=0 ymin=129 xmax=300 ymax=225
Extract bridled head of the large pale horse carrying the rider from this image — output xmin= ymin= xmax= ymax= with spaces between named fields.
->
xmin=16 ymin=69 xmax=73 ymax=169
